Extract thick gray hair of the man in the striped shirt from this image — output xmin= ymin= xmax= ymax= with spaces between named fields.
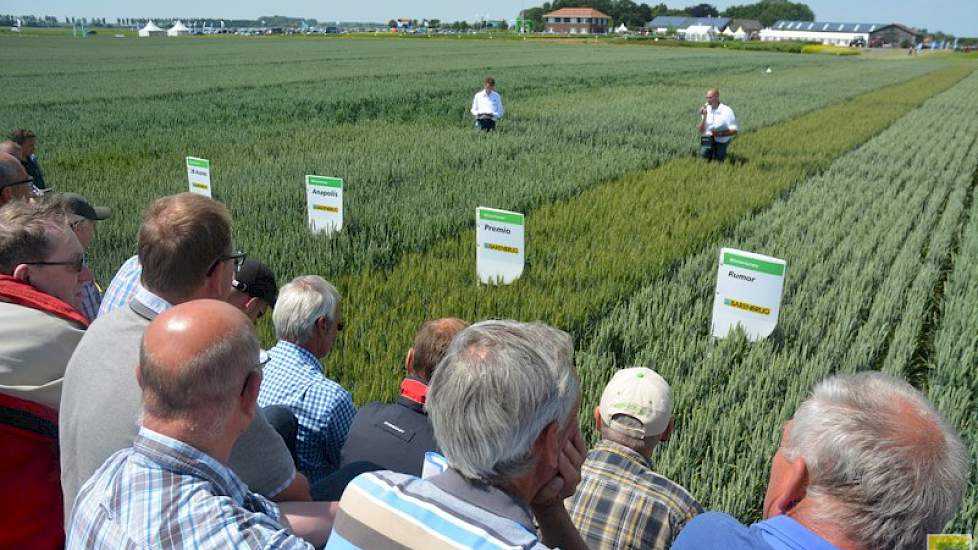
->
xmin=426 ymin=321 xmax=581 ymax=485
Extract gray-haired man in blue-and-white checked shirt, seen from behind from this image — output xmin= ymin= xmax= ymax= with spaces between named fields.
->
xmin=258 ymin=275 xmax=356 ymax=483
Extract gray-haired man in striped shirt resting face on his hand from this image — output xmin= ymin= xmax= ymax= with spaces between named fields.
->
xmin=327 ymin=321 xmax=586 ymax=550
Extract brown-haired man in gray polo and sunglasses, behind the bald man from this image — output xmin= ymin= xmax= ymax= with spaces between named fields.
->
xmin=60 ymin=193 xmax=309 ymax=528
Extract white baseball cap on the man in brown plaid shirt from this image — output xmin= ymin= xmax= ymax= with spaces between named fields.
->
xmin=600 ymin=367 xmax=672 ymax=439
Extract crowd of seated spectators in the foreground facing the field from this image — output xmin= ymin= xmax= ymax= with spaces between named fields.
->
xmin=0 ymin=126 xmax=971 ymax=550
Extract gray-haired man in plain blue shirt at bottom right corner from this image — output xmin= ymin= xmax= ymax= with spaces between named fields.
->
xmin=673 ymin=372 xmax=969 ymax=550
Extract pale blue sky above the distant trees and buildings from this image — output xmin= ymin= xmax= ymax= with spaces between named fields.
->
xmin=7 ymin=0 xmax=978 ymax=36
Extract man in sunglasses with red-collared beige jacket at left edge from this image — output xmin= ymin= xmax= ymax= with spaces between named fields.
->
xmin=0 ymin=200 xmax=88 ymax=548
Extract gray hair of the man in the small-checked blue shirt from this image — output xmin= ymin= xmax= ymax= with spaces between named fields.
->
xmin=272 ymin=275 xmax=340 ymax=343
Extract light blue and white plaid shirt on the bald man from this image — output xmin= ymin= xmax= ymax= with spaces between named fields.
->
xmin=67 ymin=428 xmax=312 ymax=550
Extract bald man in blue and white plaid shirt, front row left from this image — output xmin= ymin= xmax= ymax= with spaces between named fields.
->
xmin=67 ymin=300 xmax=334 ymax=549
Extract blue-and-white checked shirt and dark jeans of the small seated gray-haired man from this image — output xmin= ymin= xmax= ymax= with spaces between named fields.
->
xmin=258 ymin=340 xmax=357 ymax=483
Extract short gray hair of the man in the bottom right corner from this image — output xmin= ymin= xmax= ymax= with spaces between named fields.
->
xmin=784 ymin=372 xmax=968 ymax=550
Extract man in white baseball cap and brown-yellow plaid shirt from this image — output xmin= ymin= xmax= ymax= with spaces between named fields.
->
xmin=567 ymin=367 xmax=703 ymax=549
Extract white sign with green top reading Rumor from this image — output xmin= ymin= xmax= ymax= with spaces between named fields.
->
xmin=713 ymin=248 xmax=787 ymax=341
